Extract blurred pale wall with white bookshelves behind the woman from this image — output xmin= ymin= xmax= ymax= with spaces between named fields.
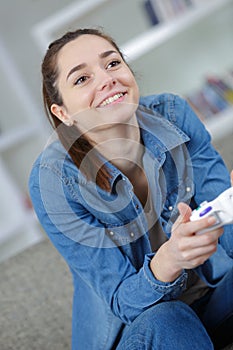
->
xmin=0 ymin=0 xmax=233 ymax=261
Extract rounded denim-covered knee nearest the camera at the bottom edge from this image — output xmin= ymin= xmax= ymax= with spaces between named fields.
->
xmin=117 ymin=301 xmax=214 ymax=350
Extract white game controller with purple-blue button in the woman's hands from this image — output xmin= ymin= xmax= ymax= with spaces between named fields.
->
xmin=190 ymin=187 xmax=233 ymax=233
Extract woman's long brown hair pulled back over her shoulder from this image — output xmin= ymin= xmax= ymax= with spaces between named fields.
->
xmin=42 ymin=28 xmax=128 ymax=191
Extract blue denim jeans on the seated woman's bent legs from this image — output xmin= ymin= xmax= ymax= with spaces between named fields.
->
xmin=117 ymin=270 xmax=233 ymax=350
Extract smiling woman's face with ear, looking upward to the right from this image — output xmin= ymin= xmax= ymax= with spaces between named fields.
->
xmin=51 ymin=34 xmax=139 ymax=135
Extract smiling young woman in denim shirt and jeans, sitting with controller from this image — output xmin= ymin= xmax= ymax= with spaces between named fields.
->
xmin=29 ymin=29 xmax=233 ymax=350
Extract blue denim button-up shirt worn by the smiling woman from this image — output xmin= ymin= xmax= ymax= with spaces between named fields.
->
xmin=29 ymin=94 xmax=233 ymax=350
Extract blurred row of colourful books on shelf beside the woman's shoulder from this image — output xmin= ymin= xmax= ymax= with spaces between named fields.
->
xmin=185 ymin=72 xmax=233 ymax=121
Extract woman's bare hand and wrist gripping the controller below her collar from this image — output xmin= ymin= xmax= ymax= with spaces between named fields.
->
xmin=150 ymin=201 xmax=223 ymax=282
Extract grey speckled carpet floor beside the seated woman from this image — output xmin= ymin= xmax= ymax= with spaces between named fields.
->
xmin=0 ymin=239 xmax=233 ymax=350
